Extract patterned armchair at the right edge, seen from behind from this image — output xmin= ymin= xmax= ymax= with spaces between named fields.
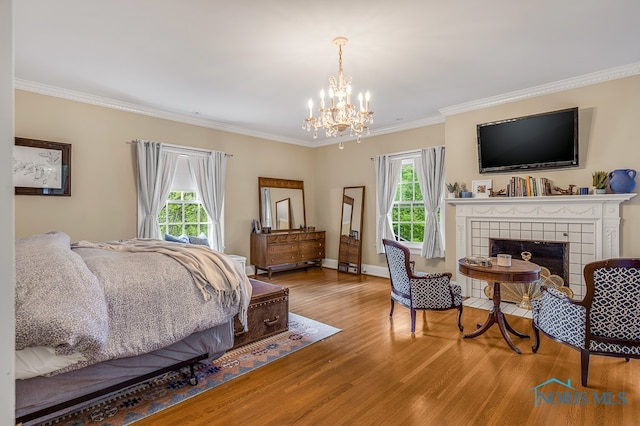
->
xmin=532 ymin=259 xmax=640 ymax=386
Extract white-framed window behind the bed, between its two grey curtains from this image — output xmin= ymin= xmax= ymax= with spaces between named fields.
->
xmin=158 ymin=191 xmax=211 ymax=241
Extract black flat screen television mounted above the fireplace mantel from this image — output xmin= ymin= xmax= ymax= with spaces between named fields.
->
xmin=477 ymin=107 xmax=578 ymax=173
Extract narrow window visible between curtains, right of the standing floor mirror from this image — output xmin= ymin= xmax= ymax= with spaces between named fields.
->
xmin=391 ymin=158 xmax=424 ymax=247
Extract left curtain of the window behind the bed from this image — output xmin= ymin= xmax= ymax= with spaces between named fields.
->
xmin=136 ymin=140 xmax=178 ymax=239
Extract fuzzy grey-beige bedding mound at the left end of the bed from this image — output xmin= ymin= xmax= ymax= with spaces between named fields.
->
xmin=15 ymin=232 xmax=109 ymax=358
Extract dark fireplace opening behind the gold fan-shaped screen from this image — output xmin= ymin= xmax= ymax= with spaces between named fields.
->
xmin=489 ymin=238 xmax=569 ymax=286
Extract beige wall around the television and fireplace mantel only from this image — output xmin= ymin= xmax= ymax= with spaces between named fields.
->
xmin=445 ymin=76 xmax=640 ymax=271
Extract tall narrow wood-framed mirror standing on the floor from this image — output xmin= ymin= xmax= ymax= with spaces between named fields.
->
xmin=338 ymin=186 xmax=364 ymax=275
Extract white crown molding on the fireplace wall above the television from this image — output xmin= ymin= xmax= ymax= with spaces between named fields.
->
xmin=438 ymin=62 xmax=640 ymax=117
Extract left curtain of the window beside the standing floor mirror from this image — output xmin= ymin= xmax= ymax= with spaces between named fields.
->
xmin=373 ymin=155 xmax=402 ymax=253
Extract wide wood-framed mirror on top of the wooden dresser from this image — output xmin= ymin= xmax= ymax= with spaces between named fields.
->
xmin=258 ymin=177 xmax=307 ymax=232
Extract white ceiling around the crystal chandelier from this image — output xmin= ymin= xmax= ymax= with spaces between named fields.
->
xmin=14 ymin=0 xmax=640 ymax=146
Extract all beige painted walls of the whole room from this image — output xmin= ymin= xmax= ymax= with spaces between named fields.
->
xmin=16 ymin=76 xmax=640 ymax=271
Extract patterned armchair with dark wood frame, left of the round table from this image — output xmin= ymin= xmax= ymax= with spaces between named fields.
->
xmin=382 ymin=239 xmax=463 ymax=333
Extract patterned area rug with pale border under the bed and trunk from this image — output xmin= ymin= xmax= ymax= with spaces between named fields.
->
xmin=28 ymin=313 xmax=340 ymax=426
